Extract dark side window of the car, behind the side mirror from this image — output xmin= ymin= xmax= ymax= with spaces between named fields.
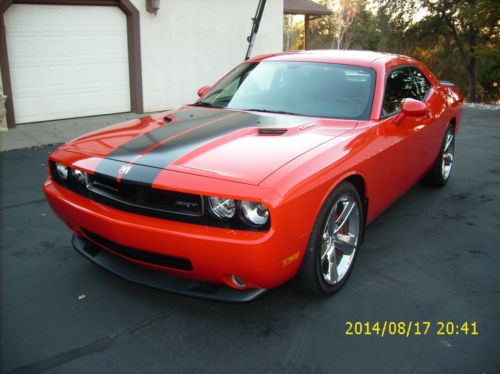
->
xmin=382 ymin=66 xmax=431 ymax=116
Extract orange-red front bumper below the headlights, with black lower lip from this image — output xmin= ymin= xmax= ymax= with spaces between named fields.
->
xmin=44 ymin=177 xmax=308 ymax=302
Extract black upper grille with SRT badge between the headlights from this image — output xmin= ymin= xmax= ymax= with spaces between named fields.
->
xmin=87 ymin=175 xmax=203 ymax=217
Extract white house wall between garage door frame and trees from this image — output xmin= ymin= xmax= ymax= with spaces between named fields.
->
xmin=132 ymin=0 xmax=283 ymax=112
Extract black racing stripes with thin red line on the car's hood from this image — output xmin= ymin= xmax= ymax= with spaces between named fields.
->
xmin=96 ymin=107 xmax=308 ymax=185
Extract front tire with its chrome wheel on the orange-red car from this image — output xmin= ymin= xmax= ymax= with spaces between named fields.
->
xmin=297 ymin=182 xmax=364 ymax=295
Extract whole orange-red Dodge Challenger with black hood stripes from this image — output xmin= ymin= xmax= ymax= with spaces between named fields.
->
xmin=44 ymin=51 xmax=463 ymax=302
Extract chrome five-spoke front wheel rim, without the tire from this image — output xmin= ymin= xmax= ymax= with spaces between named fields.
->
xmin=320 ymin=194 xmax=361 ymax=285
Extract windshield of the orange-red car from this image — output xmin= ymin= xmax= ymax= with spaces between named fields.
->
xmin=196 ymin=61 xmax=375 ymax=120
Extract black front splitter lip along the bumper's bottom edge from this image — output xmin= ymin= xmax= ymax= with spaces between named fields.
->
xmin=72 ymin=235 xmax=268 ymax=303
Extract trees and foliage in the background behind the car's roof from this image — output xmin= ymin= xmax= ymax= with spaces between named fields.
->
xmin=284 ymin=0 xmax=500 ymax=101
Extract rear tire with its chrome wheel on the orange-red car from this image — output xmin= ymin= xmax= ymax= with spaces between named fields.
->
xmin=424 ymin=123 xmax=455 ymax=187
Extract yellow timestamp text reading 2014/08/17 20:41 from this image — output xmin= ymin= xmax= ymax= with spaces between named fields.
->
xmin=345 ymin=321 xmax=479 ymax=338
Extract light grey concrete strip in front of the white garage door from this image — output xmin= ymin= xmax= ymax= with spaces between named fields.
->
xmin=0 ymin=113 xmax=152 ymax=152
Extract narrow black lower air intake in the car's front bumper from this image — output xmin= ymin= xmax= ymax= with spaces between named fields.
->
xmin=80 ymin=228 xmax=193 ymax=270
